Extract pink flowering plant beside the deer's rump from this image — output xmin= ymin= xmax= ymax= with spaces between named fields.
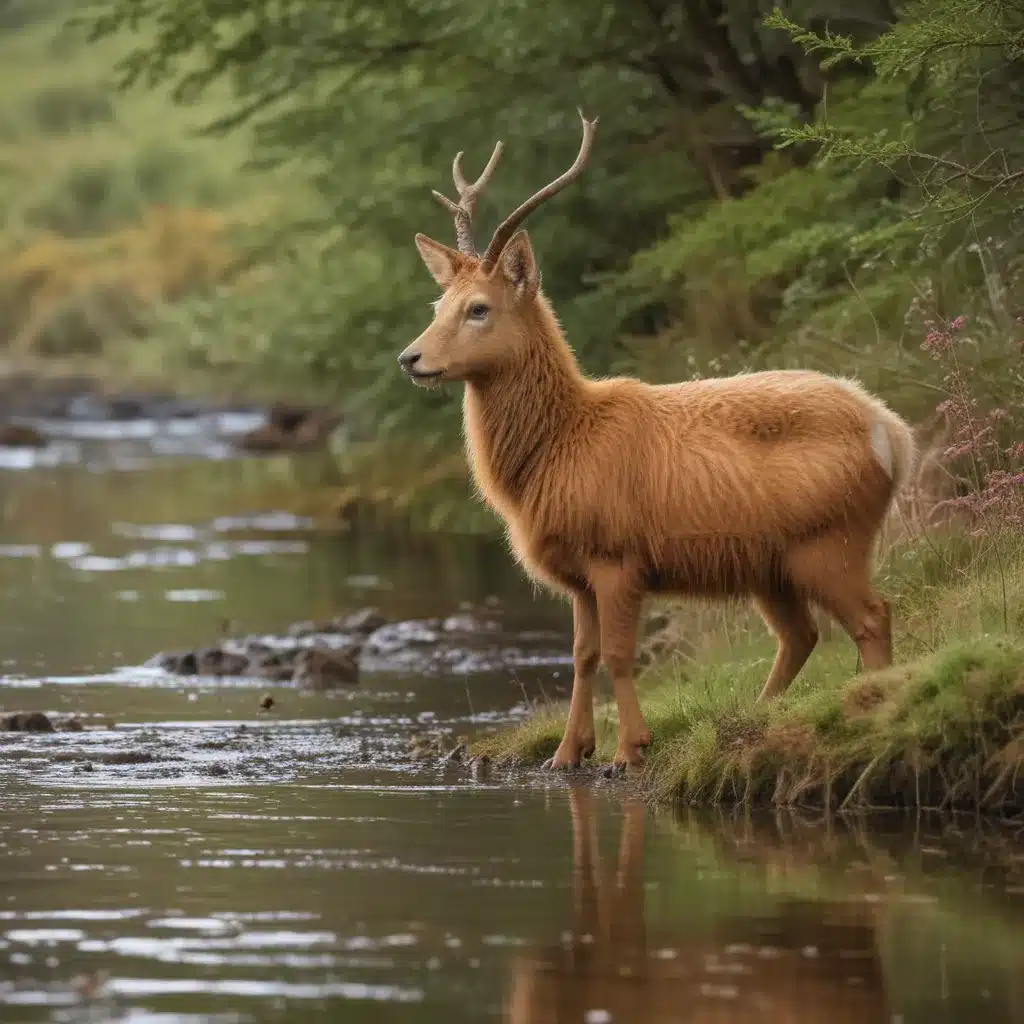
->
xmin=922 ymin=316 xmax=1024 ymax=537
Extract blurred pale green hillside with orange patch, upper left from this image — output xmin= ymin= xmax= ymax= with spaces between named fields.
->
xmin=0 ymin=0 xmax=319 ymax=372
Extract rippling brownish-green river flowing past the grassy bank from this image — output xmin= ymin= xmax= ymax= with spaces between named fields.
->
xmin=0 ymin=403 xmax=1024 ymax=1024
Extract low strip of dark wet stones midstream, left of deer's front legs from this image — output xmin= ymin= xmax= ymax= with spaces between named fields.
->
xmin=145 ymin=599 xmax=568 ymax=690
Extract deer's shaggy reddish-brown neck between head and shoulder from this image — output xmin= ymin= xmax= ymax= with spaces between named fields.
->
xmin=463 ymin=297 xmax=585 ymax=506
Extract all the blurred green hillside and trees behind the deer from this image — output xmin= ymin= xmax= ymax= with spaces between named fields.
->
xmin=0 ymin=0 xmax=1024 ymax=528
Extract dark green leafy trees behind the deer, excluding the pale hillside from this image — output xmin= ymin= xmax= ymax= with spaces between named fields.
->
xmin=79 ymin=0 xmax=1024 ymax=528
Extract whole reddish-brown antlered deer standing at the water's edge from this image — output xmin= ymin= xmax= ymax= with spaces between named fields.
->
xmin=398 ymin=113 xmax=915 ymax=768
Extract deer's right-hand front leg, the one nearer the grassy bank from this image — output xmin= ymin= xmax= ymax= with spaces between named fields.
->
xmin=590 ymin=562 xmax=651 ymax=769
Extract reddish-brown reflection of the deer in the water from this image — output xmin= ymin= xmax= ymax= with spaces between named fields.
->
xmin=505 ymin=787 xmax=890 ymax=1024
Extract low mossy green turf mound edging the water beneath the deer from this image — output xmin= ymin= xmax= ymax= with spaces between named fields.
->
xmin=474 ymin=636 xmax=1024 ymax=811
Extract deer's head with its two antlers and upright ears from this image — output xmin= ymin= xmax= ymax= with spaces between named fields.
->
xmin=398 ymin=112 xmax=597 ymax=385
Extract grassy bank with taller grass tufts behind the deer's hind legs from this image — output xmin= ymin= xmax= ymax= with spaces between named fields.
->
xmin=475 ymin=542 xmax=1024 ymax=812
